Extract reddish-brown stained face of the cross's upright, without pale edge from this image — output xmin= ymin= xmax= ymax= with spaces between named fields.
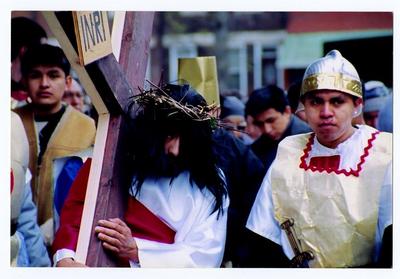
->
xmin=86 ymin=12 xmax=154 ymax=266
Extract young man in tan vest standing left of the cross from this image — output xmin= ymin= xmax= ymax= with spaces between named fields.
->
xmin=15 ymin=44 xmax=96 ymax=245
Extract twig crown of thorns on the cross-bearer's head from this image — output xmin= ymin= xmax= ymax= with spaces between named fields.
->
xmin=132 ymin=82 xmax=217 ymax=122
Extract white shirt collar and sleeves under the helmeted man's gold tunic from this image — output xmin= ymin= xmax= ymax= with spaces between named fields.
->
xmin=246 ymin=125 xmax=392 ymax=260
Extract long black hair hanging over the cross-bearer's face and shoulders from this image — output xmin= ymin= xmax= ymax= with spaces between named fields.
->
xmin=126 ymin=84 xmax=227 ymax=217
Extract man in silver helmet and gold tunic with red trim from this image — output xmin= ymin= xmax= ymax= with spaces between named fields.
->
xmin=246 ymin=50 xmax=392 ymax=267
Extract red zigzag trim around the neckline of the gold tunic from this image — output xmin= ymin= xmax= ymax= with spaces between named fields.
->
xmin=299 ymin=131 xmax=380 ymax=177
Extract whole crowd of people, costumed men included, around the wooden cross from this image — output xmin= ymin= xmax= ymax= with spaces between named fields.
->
xmin=10 ymin=18 xmax=393 ymax=268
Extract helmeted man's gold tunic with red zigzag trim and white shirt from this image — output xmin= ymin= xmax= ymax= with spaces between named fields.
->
xmin=246 ymin=125 xmax=392 ymax=267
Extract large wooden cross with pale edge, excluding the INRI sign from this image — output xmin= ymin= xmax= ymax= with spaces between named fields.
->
xmin=42 ymin=11 xmax=154 ymax=267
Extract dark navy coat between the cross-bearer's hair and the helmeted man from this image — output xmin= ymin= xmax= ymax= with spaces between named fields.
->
xmin=213 ymin=129 xmax=265 ymax=266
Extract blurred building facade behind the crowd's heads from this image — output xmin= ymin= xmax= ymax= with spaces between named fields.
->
xmin=149 ymin=12 xmax=393 ymax=101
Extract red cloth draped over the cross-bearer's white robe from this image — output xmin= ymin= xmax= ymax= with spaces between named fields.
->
xmin=52 ymin=159 xmax=176 ymax=262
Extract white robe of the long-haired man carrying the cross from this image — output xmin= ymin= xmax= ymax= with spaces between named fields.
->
xmin=54 ymin=172 xmax=229 ymax=268
